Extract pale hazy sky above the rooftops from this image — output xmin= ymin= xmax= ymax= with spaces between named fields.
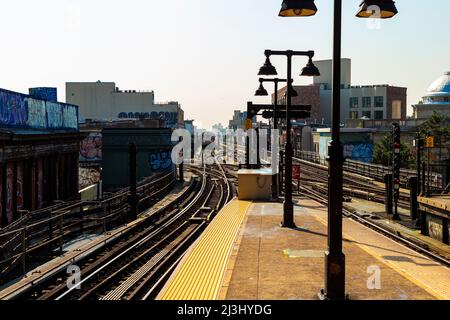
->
xmin=0 ymin=0 xmax=450 ymax=127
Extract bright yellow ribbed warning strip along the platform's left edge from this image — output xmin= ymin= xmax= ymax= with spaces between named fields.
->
xmin=157 ymin=199 xmax=251 ymax=300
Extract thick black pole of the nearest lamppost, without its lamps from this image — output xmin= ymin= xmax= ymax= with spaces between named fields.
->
xmin=320 ymin=0 xmax=346 ymax=300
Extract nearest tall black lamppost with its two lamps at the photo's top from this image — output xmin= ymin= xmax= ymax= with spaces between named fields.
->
xmin=279 ymin=0 xmax=398 ymax=300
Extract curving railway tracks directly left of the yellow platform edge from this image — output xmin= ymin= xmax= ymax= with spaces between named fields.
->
xmin=6 ymin=162 xmax=234 ymax=300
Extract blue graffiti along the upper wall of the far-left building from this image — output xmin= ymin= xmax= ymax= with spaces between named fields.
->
xmin=0 ymin=89 xmax=78 ymax=130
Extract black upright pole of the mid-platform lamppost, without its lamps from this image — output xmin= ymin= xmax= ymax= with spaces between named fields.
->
xmin=281 ymin=51 xmax=295 ymax=228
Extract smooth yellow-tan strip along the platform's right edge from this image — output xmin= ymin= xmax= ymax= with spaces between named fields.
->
xmin=316 ymin=215 xmax=450 ymax=300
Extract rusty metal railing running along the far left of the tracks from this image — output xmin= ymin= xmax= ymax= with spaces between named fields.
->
xmin=0 ymin=171 xmax=176 ymax=283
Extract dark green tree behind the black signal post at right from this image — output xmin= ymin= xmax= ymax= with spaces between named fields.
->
xmin=373 ymin=134 xmax=414 ymax=168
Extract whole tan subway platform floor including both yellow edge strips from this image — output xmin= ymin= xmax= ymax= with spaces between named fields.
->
xmin=158 ymin=198 xmax=450 ymax=300
